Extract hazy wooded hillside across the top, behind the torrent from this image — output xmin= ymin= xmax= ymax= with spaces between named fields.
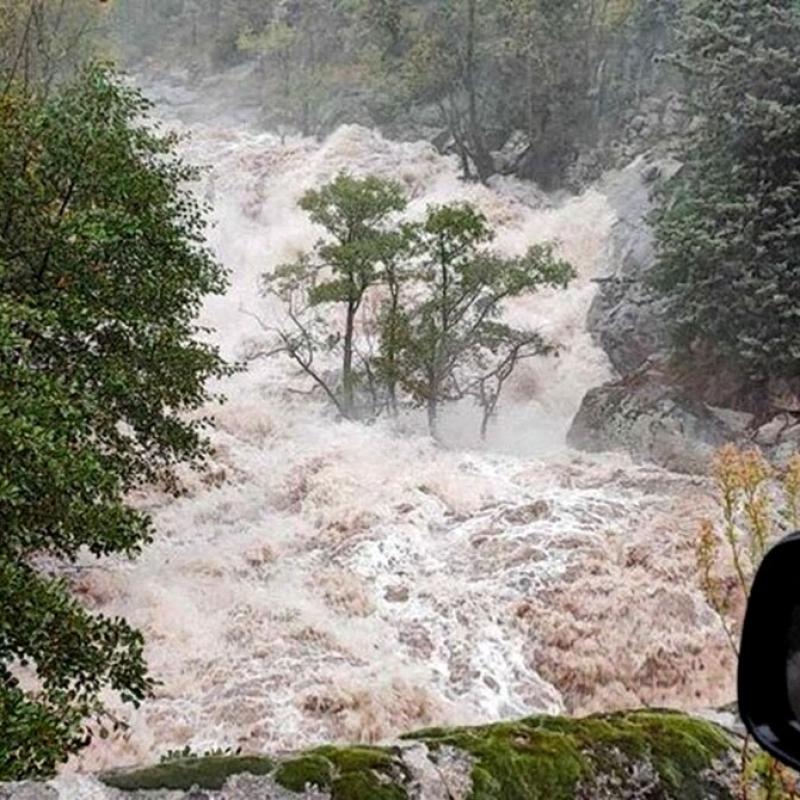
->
xmin=106 ymin=0 xmax=679 ymax=187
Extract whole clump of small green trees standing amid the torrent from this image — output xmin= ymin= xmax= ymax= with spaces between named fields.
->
xmin=262 ymin=175 xmax=574 ymax=435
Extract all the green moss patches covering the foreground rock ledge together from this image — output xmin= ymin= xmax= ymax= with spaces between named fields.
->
xmin=102 ymin=711 xmax=732 ymax=800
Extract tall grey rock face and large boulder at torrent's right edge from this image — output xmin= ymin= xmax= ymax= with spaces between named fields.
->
xmin=568 ymin=157 xmax=751 ymax=473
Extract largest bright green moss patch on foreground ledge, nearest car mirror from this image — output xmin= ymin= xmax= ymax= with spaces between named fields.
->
xmin=409 ymin=712 xmax=731 ymax=800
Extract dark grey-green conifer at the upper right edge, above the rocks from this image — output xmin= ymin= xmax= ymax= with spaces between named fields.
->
xmin=656 ymin=0 xmax=800 ymax=394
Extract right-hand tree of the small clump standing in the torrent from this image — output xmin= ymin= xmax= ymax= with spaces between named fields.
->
xmin=401 ymin=205 xmax=575 ymax=435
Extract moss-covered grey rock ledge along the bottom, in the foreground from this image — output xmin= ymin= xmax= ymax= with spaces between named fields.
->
xmin=0 ymin=711 xmax=736 ymax=800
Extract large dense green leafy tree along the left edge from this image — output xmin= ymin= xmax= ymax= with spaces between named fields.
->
xmin=0 ymin=67 xmax=227 ymax=779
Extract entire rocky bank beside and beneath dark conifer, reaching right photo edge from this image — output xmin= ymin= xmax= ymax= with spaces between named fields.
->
xmin=568 ymin=156 xmax=800 ymax=473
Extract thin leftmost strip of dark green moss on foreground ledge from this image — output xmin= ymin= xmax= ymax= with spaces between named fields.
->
xmin=100 ymin=756 xmax=275 ymax=791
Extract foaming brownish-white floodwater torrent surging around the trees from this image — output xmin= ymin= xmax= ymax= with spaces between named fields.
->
xmin=72 ymin=111 xmax=733 ymax=770
